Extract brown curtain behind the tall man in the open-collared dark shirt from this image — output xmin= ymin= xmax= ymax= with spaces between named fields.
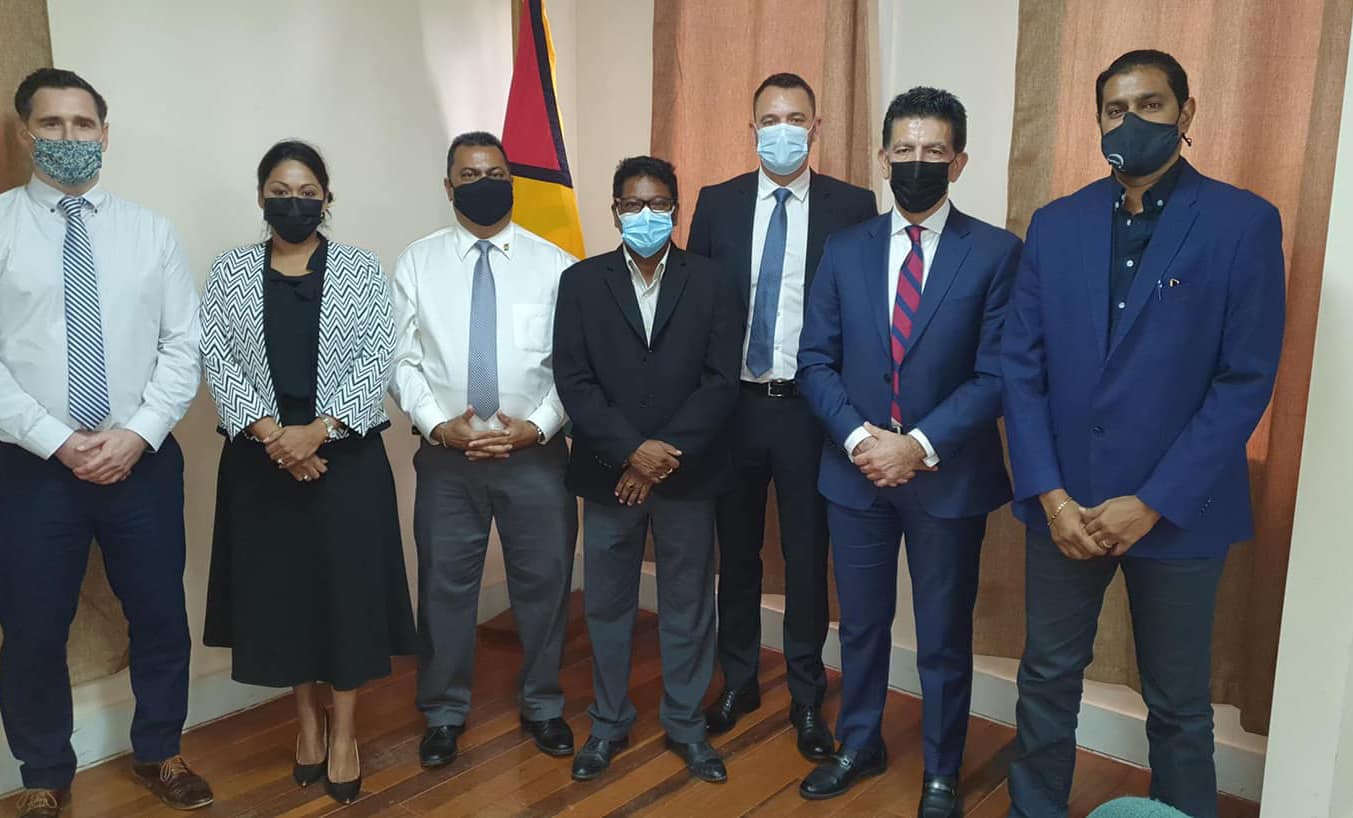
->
xmin=977 ymin=0 xmax=1353 ymax=733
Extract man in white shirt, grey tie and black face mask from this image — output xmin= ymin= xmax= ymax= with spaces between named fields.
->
xmin=394 ymin=131 xmax=578 ymax=767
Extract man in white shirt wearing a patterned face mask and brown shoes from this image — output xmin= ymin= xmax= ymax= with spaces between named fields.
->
xmin=0 ymin=69 xmax=211 ymax=818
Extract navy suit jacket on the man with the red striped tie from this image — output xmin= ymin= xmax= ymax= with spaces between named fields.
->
xmin=798 ymin=208 xmax=1020 ymax=518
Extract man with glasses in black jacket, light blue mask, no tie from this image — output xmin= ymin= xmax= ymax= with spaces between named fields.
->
xmin=553 ymin=157 xmax=743 ymax=781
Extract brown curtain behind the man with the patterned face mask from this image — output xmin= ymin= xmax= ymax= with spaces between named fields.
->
xmin=0 ymin=0 xmax=127 ymax=684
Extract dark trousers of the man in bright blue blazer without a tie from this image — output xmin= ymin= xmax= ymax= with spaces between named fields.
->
xmin=1009 ymin=529 xmax=1226 ymax=818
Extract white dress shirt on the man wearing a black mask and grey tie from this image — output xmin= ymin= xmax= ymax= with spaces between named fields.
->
xmin=392 ymin=222 xmax=576 ymax=443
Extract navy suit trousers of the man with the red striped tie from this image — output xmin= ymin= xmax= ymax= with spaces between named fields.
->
xmin=827 ymin=485 xmax=986 ymax=776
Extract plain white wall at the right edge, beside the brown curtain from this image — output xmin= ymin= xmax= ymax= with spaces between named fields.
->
xmin=1264 ymin=33 xmax=1353 ymax=818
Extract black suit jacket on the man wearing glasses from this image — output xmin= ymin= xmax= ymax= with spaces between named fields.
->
xmin=553 ymin=245 xmax=746 ymax=503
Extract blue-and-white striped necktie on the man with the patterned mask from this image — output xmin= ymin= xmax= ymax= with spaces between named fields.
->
xmin=61 ymin=196 xmax=108 ymax=429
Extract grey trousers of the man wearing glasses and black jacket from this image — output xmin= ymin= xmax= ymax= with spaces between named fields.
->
xmin=583 ymin=486 xmax=716 ymax=744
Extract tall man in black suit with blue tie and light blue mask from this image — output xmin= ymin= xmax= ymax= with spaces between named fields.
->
xmin=687 ymin=74 xmax=878 ymax=760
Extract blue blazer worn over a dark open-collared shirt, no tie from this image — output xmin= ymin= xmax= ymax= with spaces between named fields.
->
xmin=1003 ymin=164 xmax=1284 ymax=558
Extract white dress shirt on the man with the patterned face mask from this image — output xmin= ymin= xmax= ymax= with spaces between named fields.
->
xmin=0 ymin=178 xmax=200 ymax=458
